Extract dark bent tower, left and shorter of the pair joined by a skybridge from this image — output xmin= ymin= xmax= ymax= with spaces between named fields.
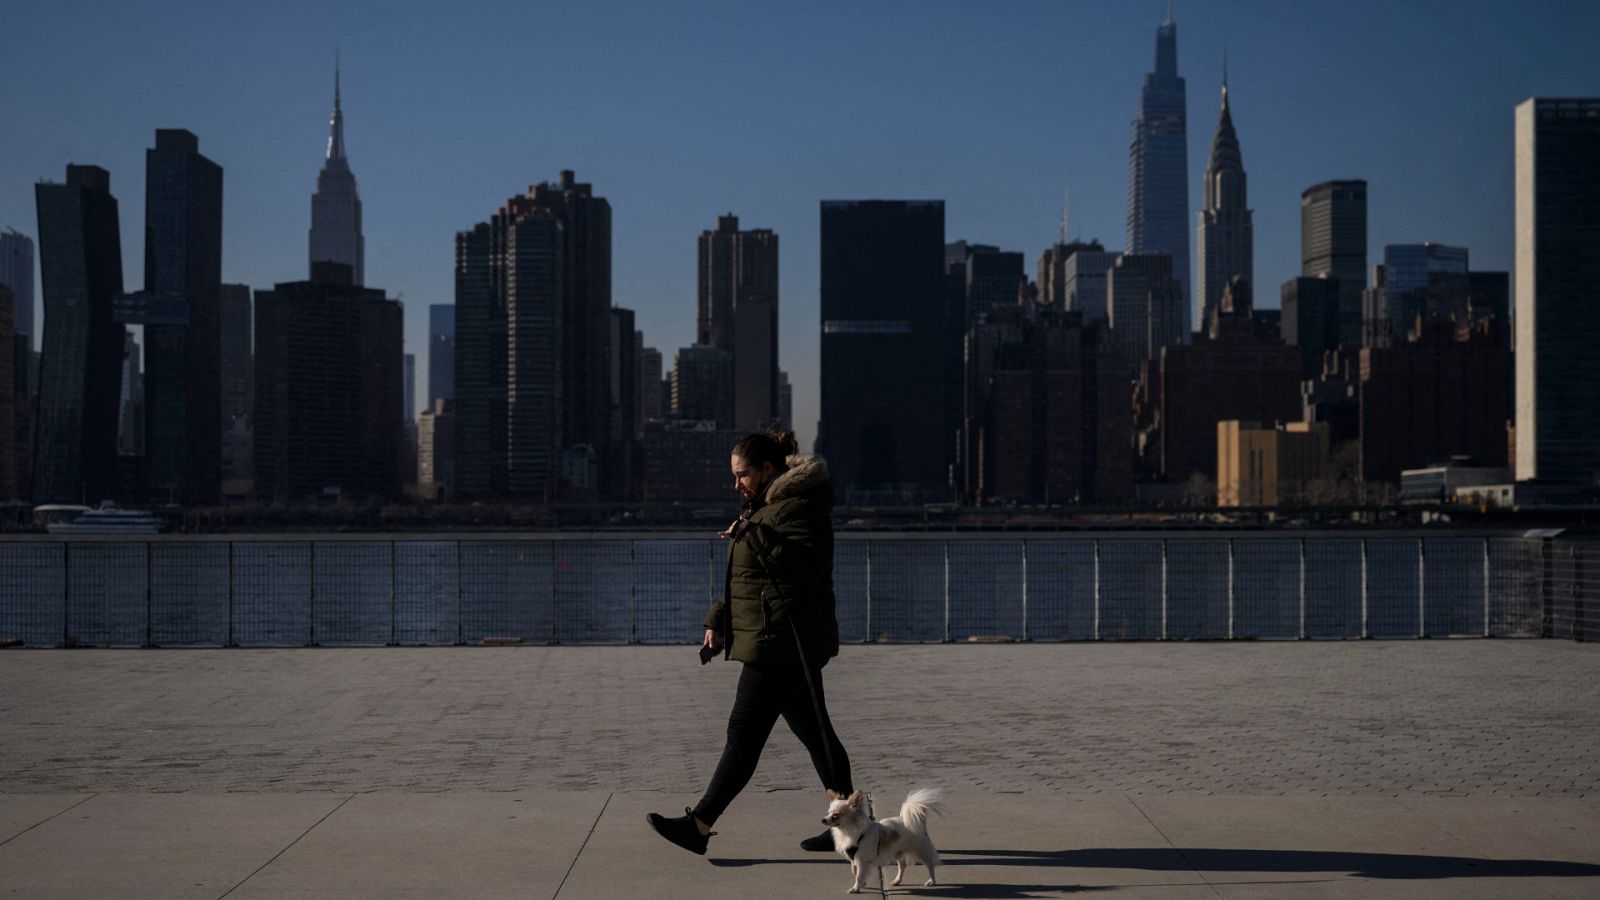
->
xmin=32 ymin=165 xmax=126 ymax=503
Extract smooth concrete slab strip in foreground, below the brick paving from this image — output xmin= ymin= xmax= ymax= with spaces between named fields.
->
xmin=0 ymin=791 xmax=1600 ymax=900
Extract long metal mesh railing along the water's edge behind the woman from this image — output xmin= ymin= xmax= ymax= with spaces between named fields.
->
xmin=0 ymin=532 xmax=1600 ymax=647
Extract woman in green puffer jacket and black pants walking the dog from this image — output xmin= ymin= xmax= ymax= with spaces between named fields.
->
xmin=645 ymin=431 xmax=853 ymax=854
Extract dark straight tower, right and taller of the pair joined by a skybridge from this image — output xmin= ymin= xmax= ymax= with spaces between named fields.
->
xmin=118 ymin=128 xmax=222 ymax=503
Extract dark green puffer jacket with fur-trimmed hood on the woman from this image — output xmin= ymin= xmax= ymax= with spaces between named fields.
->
xmin=706 ymin=455 xmax=838 ymax=666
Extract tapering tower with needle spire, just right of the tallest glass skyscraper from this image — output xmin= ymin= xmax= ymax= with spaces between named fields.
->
xmin=1194 ymin=59 xmax=1256 ymax=330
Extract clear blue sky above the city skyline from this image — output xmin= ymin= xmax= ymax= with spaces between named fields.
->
xmin=0 ymin=0 xmax=1600 ymax=442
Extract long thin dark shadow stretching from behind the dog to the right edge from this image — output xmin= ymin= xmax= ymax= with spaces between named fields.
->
xmin=939 ymin=847 xmax=1600 ymax=878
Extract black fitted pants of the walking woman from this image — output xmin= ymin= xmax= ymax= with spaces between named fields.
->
xmin=694 ymin=661 xmax=851 ymax=825
